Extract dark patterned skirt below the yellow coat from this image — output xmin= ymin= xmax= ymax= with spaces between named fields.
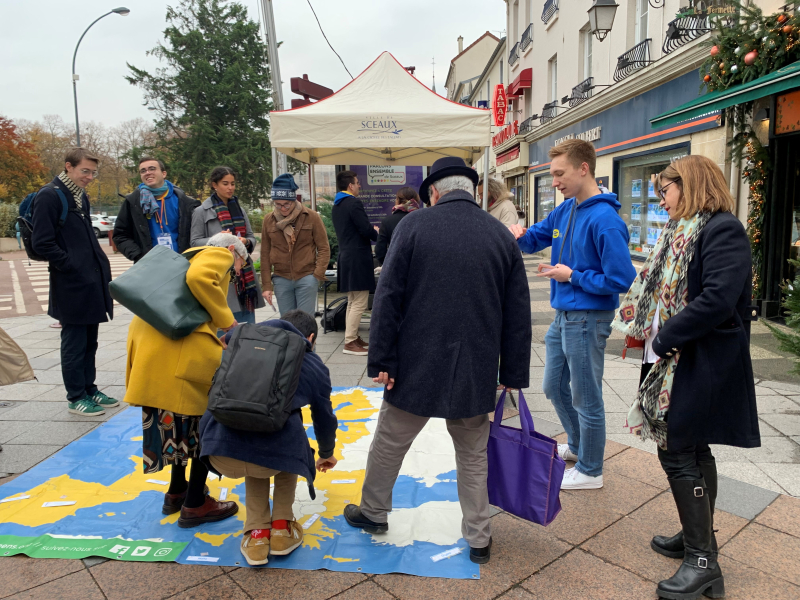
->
xmin=142 ymin=407 xmax=200 ymax=473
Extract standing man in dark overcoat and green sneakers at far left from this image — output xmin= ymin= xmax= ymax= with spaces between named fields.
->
xmin=31 ymin=148 xmax=119 ymax=417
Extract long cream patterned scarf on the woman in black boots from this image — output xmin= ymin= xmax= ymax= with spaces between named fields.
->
xmin=611 ymin=213 xmax=712 ymax=449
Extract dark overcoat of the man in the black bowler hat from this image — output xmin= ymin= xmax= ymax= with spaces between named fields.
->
xmin=367 ymin=191 xmax=531 ymax=419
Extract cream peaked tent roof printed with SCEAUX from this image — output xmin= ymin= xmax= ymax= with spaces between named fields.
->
xmin=270 ymin=52 xmax=491 ymax=166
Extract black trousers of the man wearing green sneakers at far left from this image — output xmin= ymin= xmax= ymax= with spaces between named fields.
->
xmin=61 ymin=323 xmax=100 ymax=402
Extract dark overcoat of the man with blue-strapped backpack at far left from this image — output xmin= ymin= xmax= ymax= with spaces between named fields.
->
xmin=31 ymin=177 xmax=114 ymax=325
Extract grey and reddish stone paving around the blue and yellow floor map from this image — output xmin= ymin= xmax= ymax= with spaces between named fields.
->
xmin=0 ymin=252 xmax=800 ymax=600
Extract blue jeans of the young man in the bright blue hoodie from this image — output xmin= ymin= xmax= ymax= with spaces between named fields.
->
xmin=542 ymin=310 xmax=614 ymax=477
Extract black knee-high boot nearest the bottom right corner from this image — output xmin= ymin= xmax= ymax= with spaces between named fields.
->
xmin=656 ymin=479 xmax=725 ymax=600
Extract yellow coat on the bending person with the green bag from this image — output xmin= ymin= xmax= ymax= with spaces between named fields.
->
xmin=125 ymin=246 xmax=234 ymax=416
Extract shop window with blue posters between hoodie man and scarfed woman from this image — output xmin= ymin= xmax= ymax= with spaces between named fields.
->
xmin=616 ymin=148 xmax=688 ymax=259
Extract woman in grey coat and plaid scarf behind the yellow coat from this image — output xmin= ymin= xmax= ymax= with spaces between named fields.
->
xmin=192 ymin=167 xmax=265 ymax=323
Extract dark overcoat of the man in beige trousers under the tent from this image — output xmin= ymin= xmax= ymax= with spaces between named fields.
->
xmin=331 ymin=196 xmax=378 ymax=292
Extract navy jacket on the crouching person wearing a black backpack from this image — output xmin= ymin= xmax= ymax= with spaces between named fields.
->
xmin=200 ymin=319 xmax=339 ymax=499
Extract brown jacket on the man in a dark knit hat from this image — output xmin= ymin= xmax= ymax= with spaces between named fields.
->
xmin=261 ymin=206 xmax=331 ymax=291
